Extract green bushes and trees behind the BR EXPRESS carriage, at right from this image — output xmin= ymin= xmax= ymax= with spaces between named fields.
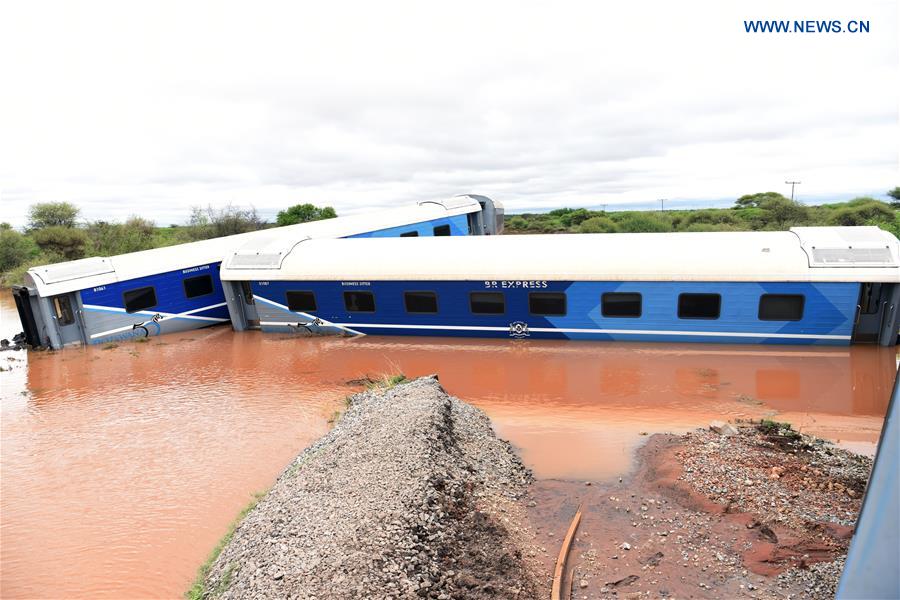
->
xmin=505 ymin=188 xmax=900 ymax=238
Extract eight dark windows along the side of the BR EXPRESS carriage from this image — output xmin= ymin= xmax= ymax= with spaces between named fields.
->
xmin=287 ymin=291 xmax=804 ymax=321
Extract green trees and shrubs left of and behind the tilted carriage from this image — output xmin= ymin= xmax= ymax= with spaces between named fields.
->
xmin=0 ymin=202 xmax=337 ymax=285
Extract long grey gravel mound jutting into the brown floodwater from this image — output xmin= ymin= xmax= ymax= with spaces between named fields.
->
xmin=206 ymin=377 xmax=542 ymax=599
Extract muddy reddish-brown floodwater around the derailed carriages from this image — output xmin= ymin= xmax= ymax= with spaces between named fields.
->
xmin=0 ymin=294 xmax=897 ymax=598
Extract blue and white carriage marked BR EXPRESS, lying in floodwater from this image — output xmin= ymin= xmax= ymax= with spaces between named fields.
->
xmin=222 ymin=227 xmax=900 ymax=345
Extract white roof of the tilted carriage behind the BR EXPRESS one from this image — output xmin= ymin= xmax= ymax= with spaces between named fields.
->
xmin=28 ymin=195 xmax=481 ymax=296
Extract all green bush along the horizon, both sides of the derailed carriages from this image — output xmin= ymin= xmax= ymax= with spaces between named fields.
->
xmin=0 ymin=188 xmax=900 ymax=285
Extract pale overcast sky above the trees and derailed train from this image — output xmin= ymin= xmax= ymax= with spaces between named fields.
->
xmin=0 ymin=1 xmax=900 ymax=225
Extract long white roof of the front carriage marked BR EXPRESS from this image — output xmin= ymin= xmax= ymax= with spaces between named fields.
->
xmin=222 ymin=227 xmax=900 ymax=282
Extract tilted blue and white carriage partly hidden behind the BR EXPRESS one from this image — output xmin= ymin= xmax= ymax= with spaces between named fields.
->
xmin=14 ymin=195 xmax=503 ymax=348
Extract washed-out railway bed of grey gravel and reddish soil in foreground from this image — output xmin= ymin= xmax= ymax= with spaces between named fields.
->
xmin=194 ymin=377 xmax=871 ymax=600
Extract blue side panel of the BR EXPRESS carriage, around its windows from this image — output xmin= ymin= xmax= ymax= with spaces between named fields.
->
xmin=244 ymin=281 xmax=859 ymax=344
